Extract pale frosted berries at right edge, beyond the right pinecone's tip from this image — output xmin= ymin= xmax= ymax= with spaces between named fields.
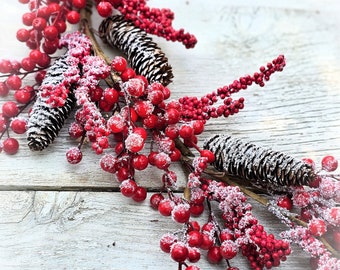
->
xmin=271 ymin=156 xmax=340 ymax=269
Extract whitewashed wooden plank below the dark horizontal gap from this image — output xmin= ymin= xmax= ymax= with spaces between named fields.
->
xmin=0 ymin=191 xmax=308 ymax=270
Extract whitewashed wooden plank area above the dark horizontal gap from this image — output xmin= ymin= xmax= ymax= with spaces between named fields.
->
xmin=0 ymin=1 xmax=340 ymax=190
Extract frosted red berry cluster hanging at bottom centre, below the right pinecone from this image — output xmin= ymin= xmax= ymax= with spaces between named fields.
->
xmin=155 ymin=157 xmax=291 ymax=270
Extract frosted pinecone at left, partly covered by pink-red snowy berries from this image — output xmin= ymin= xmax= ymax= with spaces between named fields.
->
xmin=27 ymin=56 xmax=75 ymax=151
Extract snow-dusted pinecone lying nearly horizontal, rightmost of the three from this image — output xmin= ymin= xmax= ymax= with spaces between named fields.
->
xmin=204 ymin=135 xmax=315 ymax=186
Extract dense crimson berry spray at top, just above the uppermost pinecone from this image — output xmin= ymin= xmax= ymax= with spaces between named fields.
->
xmin=96 ymin=0 xmax=197 ymax=48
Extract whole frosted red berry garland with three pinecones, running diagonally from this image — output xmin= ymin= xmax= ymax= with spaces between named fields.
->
xmin=0 ymin=0 xmax=340 ymax=270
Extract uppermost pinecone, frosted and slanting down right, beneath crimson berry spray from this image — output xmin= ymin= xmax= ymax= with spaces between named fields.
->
xmin=99 ymin=15 xmax=173 ymax=85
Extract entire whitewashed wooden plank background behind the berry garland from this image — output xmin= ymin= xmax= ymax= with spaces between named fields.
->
xmin=0 ymin=0 xmax=340 ymax=269
